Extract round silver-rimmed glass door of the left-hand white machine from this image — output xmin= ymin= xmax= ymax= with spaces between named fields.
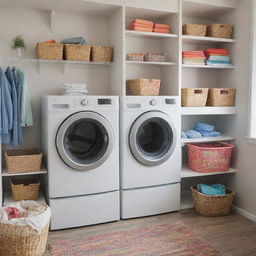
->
xmin=56 ymin=112 xmax=114 ymax=171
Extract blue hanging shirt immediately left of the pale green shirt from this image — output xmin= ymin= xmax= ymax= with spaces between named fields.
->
xmin=12 ymin=67 xmax=23 ymax=144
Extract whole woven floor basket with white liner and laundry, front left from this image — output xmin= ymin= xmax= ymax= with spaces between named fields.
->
xmin=0 ymin=201 xmax=51 ymax=256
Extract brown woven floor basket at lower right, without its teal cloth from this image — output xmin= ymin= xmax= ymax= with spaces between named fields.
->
xmin=191 ymin=185 xmax=235 ymax=217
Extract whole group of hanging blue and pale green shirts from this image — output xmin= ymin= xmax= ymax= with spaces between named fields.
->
xmin=0 ymin=67 xmax=33 ymax=146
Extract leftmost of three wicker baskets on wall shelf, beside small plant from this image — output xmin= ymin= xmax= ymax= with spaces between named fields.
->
xmin=36 ymin=42 xmax=63 ymax=60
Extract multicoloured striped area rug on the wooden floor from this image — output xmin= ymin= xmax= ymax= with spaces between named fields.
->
xmin=50 ymin=222 xmax=221 ymax=256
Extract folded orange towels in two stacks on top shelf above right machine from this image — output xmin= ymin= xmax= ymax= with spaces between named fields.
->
xmin=129 ymin=19 xmax=170 ymax=33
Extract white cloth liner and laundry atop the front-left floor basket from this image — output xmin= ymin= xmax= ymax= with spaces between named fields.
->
xmin=0 ymin=200 xmax=51 ymax=232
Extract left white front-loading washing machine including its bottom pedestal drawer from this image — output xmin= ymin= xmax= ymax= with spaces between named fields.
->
xmin=42 ymin=96 xmax=120 ymax=230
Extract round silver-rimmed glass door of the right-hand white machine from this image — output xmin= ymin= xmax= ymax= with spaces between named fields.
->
xmin=129 ymin=111 xmax=177 ymax=166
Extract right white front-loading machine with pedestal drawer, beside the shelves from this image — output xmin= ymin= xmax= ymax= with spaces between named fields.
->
xmin=120 ymin=96 xmax=181 ymax=219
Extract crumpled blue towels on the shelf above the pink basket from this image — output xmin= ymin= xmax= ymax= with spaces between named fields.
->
xmin=181 ymin=123 xmax=221 ymax=139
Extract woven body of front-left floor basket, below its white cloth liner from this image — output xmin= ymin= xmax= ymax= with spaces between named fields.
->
xmin=0 ymin=221 xmax=49 ymax=256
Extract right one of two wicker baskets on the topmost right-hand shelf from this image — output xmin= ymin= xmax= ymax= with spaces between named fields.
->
xmin=206 ymin=24 xmax=233 ymax=38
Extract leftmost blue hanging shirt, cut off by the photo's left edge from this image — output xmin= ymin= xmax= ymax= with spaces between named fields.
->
xmin=0 ymin=67 xmax=13 ymax=144
